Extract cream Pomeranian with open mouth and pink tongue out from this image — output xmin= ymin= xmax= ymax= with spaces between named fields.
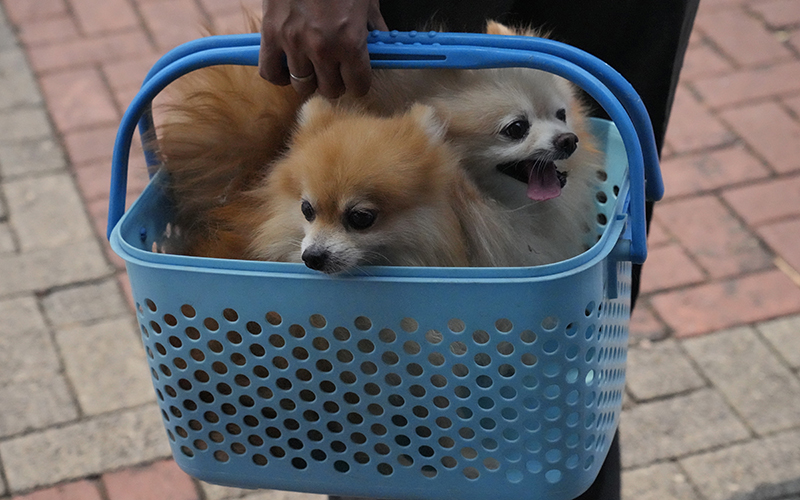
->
xmin=346 ymin=22 xmax=604 ymax=265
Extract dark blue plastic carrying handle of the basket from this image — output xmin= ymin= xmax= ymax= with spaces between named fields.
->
xmin=107 ymin=32 xmax=663 ymax=263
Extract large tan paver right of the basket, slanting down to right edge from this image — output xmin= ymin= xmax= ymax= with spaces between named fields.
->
xmin=683 ymin=327 xmax=800 ymax=435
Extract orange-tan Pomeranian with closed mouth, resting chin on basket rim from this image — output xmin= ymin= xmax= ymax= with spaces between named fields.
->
xmin=178 ymin=97 xmax=519 ymax=274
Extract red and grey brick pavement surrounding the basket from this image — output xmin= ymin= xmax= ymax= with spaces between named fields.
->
xmin=0 ymin=0 xmax=800 ymax=500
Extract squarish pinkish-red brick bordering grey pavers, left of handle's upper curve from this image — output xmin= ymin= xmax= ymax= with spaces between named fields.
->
xmin=41 ymin=68 xmax=120 ymax=132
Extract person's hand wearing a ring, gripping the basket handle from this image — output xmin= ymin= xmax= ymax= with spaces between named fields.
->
xmin=258 ymin=0 xmax=387 ymax=98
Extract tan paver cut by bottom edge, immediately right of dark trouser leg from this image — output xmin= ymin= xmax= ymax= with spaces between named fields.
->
xmin=622 ymin=460 xmax=701 ymax=500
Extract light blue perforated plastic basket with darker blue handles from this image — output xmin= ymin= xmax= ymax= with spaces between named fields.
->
xmin=109 ymin=32 xmax=662 ymax=500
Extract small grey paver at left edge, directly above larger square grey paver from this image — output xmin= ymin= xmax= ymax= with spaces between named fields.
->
xmin=0 ymin=137 xmax=66 ymax=179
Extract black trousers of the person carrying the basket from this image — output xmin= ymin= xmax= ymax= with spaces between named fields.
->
xmin=331 ymin=0 xmax=699 ymax=500
